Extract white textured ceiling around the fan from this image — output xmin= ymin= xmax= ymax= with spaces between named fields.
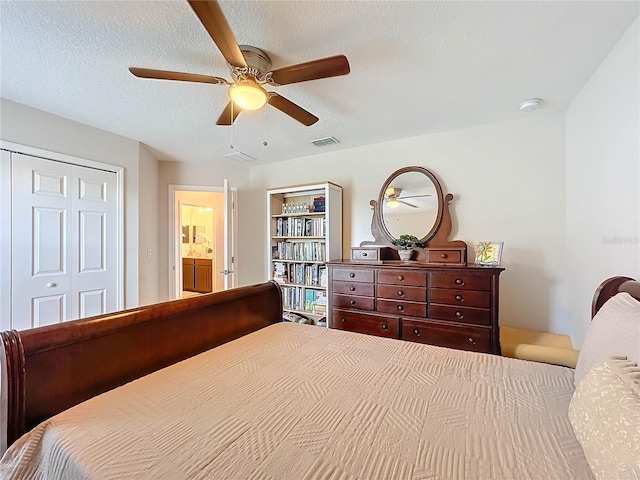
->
xmin=0 ymin=0 xmax=640 ymax=165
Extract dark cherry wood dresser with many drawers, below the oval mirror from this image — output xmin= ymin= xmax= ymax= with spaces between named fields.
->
xmin=328 ymin=260 xmax=504 ymax=354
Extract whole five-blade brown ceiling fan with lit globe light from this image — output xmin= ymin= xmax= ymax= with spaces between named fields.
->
xmin=129 ymin=0 xmax=350 ymax=126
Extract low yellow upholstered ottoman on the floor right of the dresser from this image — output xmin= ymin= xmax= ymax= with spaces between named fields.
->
xmin=500 ymin=326 xmax=580 ymax=368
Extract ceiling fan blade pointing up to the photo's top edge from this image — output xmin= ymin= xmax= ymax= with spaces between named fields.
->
xmin=189 ymin=0 xmax=247 ymax=67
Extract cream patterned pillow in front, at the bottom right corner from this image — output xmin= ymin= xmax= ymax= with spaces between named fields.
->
xmin=569 ymin=357 xmax=640 ymax=480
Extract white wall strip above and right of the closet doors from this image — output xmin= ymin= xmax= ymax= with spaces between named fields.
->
xmin=0 ymin=99 xmax=156 ymax=308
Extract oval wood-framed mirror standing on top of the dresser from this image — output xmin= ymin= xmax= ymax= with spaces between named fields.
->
xmin=376 ymin=167 xmax=444 ymax=243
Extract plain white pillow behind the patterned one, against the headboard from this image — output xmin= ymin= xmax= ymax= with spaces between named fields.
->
xmin=574 ymin=292 xmax=640 ymax=386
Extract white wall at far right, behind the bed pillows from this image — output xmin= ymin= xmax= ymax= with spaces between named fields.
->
xmin=566 ymin=19 xmax=640 ymax=347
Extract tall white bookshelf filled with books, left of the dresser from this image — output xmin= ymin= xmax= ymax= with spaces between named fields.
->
xmin=267 ymin=182 xmax=342 ymax=326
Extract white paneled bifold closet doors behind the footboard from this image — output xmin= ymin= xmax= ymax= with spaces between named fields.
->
xmin=11 ymin=153 xmax=117 ymax=329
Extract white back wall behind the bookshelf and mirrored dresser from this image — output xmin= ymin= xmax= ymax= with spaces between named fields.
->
xmin=243 ymin=110 xmax=571 ymax=333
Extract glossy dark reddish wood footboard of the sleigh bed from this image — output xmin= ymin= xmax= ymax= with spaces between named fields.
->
xmin=0 ymin=282 xmax=282 ymax=453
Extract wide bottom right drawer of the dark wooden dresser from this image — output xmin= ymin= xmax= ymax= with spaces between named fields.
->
xmin=402 ymin=319 xmax=491 ymax=353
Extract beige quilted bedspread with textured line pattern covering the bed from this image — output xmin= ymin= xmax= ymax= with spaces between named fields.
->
xmin=0 ymin=323 xmax=592 ymax=480
